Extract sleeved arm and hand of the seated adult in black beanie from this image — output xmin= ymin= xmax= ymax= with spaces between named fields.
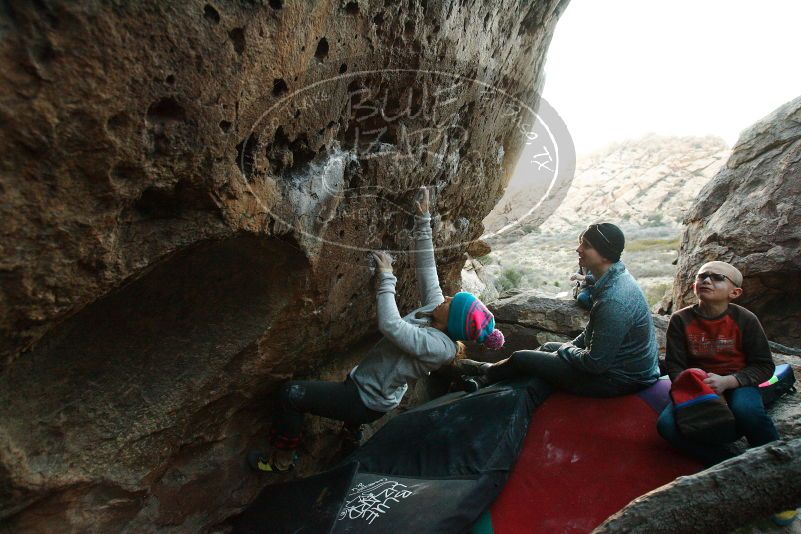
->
xmin=559 ymin=300 xmax=630 ymax=374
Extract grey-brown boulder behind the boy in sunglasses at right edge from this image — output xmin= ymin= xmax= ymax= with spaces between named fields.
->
xmin=673 ymin=98 xmax=801 ymax=346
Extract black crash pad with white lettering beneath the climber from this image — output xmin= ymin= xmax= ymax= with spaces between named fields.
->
xmin=234 ymin=378 xmax=551 ymax=533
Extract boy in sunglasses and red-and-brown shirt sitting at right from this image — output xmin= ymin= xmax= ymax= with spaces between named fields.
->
xmin=657 ymin=261 xmax=779 ymax=466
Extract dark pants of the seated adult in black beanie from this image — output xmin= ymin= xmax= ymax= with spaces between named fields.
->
xmin=486 ymin=342 xmax=647 ymax=397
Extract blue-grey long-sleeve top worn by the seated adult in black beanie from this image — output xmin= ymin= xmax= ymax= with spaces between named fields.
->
xmin=558 ymin=261 xmax=659 ymax=386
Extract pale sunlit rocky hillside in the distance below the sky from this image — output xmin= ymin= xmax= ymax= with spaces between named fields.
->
xmin=484 ymin=134 xmax=729 ymax=241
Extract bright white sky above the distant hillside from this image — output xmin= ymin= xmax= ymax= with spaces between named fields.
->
xmin=543 ymin=0 xmax=801 ymax=155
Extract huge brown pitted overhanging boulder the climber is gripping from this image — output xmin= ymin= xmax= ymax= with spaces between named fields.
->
xmin=0 ymin=0 xmax=566 ymax=532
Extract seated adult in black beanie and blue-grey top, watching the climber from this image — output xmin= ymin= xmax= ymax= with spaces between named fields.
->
xmin=457 ymin=223 xmax=659 ymax=397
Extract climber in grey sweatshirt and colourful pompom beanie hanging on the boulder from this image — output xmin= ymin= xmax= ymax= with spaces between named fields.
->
xmin=248 ymin=188 xmax=504 ymax=472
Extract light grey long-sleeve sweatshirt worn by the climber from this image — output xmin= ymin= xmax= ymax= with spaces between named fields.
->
xmin=350 ymin=213 xmax=457 ymax=412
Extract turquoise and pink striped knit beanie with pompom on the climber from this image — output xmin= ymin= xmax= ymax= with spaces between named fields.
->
xmin=448 ymin=291 xmax=504 ymax=350
